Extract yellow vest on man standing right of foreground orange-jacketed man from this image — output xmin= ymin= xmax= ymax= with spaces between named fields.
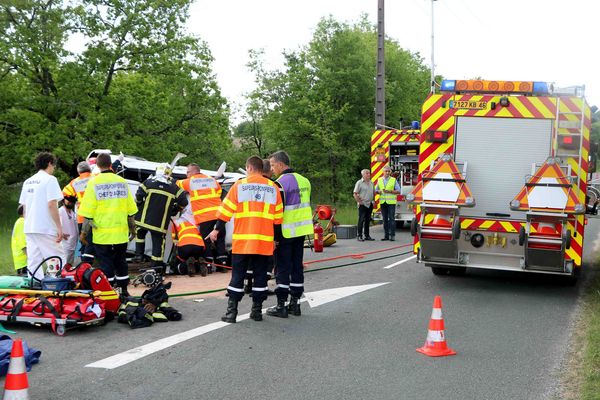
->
xmin=277 ymin=172 xmax=314 ymax=238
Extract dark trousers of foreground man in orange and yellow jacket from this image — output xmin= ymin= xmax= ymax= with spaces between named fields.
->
xmin=227 ymin=254 xmax=270 ymax=303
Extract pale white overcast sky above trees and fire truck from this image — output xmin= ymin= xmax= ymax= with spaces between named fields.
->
xmin=188 ymin=0 xmax=600 ymax=118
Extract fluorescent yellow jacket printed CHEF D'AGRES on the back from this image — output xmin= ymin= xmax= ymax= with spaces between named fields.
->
xmin=79 ymin=172 xmax=137 ymax=244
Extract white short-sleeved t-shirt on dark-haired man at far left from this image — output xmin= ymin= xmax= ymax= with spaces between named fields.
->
xmin=19 ymin=170 xmax=63 ymax=235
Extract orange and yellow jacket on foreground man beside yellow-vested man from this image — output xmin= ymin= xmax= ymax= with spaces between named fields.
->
xmin=217 ymin=175 xmax=283 ymax=256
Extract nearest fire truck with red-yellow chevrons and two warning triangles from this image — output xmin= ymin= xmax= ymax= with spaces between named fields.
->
xmin=406 ymin=80 xmax=597 ymax=282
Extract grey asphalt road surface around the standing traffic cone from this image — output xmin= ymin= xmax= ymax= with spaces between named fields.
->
xmin=5 ymin=222 xmax=599 ymax=400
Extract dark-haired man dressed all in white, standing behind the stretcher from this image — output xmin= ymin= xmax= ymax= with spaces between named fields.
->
xmin=19 ymin=152 xmax=66 ymax=280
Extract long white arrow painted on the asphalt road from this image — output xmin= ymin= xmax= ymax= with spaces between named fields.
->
xmin=86 ymin=282 xmax=390 ymax=369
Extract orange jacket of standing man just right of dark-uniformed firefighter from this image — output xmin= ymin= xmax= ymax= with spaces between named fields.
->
xmin=177 ymin=174 xmax=221 ymax=224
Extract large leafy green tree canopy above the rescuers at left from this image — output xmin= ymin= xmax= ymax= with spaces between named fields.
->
xmin=0 ymin=0 xmax=231 ymax=183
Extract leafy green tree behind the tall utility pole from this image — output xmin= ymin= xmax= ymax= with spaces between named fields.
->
xmin=239 ymin=17 xmax=429 ymax=202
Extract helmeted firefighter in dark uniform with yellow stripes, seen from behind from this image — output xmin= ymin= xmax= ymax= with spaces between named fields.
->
xmin=135 ymin=164 xmax=188 ymax=268
